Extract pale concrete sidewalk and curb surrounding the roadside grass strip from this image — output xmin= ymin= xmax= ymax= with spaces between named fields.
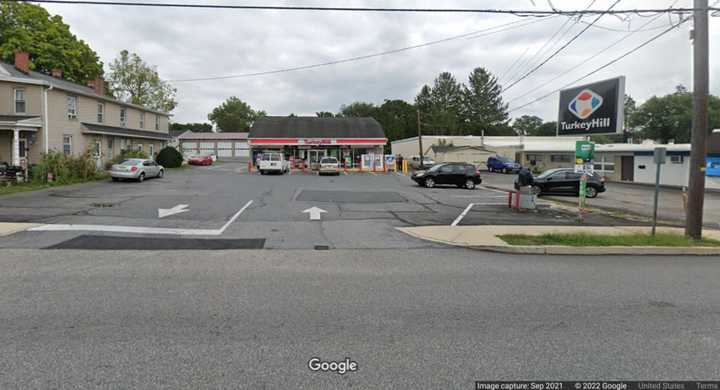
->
xmin=396 ymin=225 xmax=720 ymax=255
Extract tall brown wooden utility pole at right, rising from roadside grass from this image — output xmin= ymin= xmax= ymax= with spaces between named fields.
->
xmin=685 ymin=0 xmax=710 ymax=240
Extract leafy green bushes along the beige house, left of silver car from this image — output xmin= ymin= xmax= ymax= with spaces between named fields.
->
xmin=30 ymin=150 xmax=103 ymax=184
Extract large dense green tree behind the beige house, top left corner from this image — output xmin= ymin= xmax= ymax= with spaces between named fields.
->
xmin=0 ymin=1 xmax=103 ymax=85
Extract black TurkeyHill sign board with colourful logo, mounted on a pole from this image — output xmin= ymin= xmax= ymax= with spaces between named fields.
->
xmin=557 ymin=76 xmax=625 ymax=135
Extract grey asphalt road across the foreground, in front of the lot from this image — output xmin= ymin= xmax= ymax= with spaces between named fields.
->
xmin=0 ymin=249 xmax=720 ymax=389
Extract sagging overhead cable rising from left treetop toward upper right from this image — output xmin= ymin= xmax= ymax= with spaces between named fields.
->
xmin=168 ymin=16 xmax=554 ymax=83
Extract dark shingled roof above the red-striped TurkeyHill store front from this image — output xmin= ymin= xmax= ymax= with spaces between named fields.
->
xmin=249 ymin=116 xmax=385 ymax=138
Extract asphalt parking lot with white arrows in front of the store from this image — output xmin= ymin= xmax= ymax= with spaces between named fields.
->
xmin=0 ymin=163 xmax=637 ymax=249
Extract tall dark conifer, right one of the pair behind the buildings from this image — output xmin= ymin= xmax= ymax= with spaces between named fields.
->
xmin=462 ymin=67 xmax=513 ymax=135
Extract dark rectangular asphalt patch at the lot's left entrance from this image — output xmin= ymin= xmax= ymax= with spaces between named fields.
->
xmin=45 ymin=235 xmax=265 ymax=250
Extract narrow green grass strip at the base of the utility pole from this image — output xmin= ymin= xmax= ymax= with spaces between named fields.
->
xmin=498 ymin=233 xmax=720 ymax=247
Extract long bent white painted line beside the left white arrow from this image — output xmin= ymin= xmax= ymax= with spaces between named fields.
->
xmin=28 ymin=200 xmax=253 ymax=236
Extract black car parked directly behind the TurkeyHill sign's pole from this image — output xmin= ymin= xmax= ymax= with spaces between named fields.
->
xmin=515 ymin=168 xmax=605 ymax=198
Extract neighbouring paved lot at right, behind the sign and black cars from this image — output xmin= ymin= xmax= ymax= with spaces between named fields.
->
xmin=483 ymin=173 xmax=720 ymax=229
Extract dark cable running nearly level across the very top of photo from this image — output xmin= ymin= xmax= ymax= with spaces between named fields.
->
xmin=5 ymin=0 xmax=720 ymax=16
